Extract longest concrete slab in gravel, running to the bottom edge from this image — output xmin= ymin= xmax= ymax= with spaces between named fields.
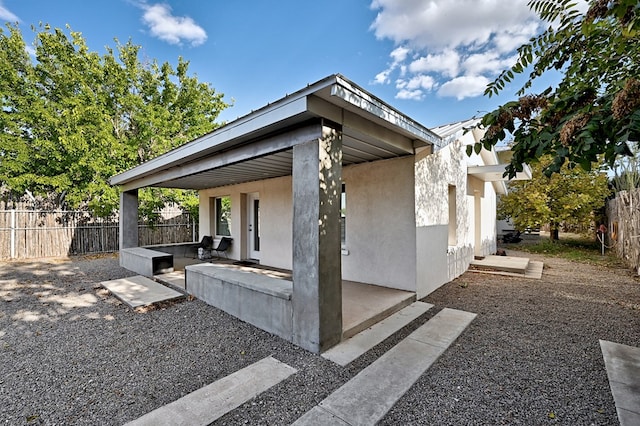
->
xmin=294 ymin=308 xmax=476 ymax=426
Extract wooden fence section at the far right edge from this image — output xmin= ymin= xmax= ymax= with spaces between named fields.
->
xmin=606 ymin=189 xmax=640 ymax=273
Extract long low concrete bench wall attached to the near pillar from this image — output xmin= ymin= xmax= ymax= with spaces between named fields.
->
xmin=185 ymin=263 xmax=293 ymax=340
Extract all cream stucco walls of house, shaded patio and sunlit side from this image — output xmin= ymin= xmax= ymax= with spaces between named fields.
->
xmin=195 ymin=141 xmax=496 ymax=298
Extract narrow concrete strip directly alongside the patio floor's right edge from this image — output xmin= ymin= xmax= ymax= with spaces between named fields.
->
xmin=322 ymin=302 xmax=433 ymax=366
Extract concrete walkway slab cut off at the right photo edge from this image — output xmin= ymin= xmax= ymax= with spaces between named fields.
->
xmin=600 ymin=340 xmax=640 ymax=426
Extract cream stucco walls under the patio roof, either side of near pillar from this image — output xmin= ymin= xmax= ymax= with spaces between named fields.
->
xmin=200 ymin=157 xmax=416 ymax=291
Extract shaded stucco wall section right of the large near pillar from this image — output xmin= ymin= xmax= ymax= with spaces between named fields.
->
xmin=342 ymin=157 xmax=416 ymax=291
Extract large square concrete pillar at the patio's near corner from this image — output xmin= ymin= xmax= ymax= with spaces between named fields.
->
xmin=292 ymin=123 xmax=342 ymax=353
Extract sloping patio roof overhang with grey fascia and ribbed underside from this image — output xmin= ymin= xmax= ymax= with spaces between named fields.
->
xmin=110 ymin=74 xmax=442 ymax=191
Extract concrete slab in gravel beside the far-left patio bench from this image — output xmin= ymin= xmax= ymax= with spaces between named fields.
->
xmin=100 ymin=275 xmax=184 ymax=308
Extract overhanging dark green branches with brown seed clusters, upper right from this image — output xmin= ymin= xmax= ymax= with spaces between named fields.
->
xmin=469 ymin=0 xmax=640 ymax=177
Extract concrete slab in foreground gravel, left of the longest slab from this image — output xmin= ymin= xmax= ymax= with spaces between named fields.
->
xmin=127 ymin=357 xmax=297 ymax=426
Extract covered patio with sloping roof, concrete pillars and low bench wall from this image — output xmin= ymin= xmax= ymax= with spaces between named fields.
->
xmin=111 ymin=75 xmax=441 ymax=352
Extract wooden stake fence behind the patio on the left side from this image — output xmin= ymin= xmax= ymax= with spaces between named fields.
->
xmin=0 ymin=209 xmax=198 ymax=259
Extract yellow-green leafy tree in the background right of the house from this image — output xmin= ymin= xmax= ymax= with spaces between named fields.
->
xmin=498 ymin=155 xmax=610 ymax=240
